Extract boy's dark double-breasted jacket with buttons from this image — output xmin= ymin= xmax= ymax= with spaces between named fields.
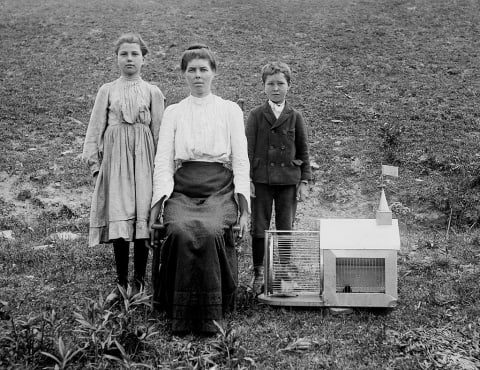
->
xmin=246 ymin=101 xmax=312 ymax=185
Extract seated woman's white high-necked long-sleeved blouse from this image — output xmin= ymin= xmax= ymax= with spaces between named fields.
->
xmin=152 ymin=94 xmax=250 ymax=209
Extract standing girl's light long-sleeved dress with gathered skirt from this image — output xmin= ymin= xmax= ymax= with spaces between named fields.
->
xmin=83 ymin=77 xmax=164 ymax=246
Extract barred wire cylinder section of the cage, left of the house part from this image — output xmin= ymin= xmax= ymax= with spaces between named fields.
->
xmin=265 ymin=230 xmax=323 ymax=295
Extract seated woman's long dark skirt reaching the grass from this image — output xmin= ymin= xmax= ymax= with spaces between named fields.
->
xmin=153 ymin=162 xmax=238 ymax=332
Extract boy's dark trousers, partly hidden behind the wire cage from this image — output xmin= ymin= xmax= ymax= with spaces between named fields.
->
xmin=252 ymin=183 xmax=297 ymax=267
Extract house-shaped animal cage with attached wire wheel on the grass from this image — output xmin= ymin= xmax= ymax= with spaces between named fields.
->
xmin=259 ymin=219 xmax=400 ymax=307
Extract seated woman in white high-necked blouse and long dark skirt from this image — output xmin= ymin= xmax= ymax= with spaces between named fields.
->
xmin=150 ymin=45 xmax=250 ymax=333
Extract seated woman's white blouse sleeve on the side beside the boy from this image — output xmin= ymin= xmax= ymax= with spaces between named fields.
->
xmin=229 ymin=102 xmax=250 ymax=212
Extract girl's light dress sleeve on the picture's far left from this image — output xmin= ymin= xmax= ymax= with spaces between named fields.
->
xmin=82 ymin=84 xmax=108 ymax=175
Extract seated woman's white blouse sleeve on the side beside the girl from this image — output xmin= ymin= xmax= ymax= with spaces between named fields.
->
xmin=152 ymin=106 xmax=175 ymax=207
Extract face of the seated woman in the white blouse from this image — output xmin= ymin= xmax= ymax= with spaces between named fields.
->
xmin=184 ymin=59 xmax=215 ymax=98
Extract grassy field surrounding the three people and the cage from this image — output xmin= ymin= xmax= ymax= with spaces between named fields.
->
xmin=0 ymin=0 xmax=480 ymax=369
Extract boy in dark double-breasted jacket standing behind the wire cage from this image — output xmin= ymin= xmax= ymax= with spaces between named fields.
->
xmin=246 ymin=62 xmax=311 ymax=294
